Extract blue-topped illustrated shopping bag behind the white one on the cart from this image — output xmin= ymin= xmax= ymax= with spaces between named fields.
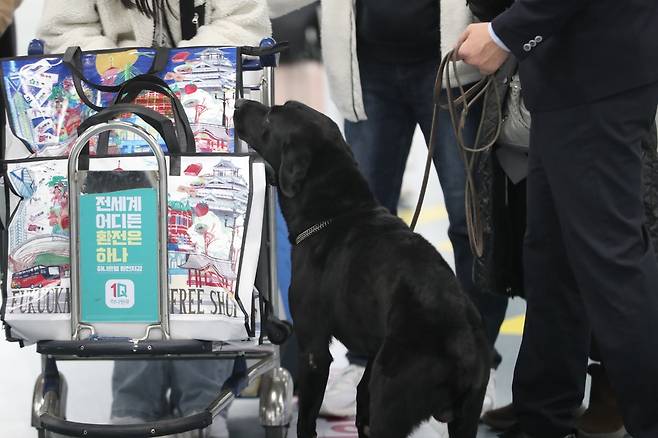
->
xmin=0 ymin=47 xmax=243 ymax=158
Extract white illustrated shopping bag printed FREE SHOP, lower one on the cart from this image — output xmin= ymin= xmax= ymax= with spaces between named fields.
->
xmin=2 ymin=104 xmax=265 ymax=341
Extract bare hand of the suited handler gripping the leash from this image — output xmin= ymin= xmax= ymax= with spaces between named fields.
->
xmin=455 ymin=23 xmax=509 ymax=75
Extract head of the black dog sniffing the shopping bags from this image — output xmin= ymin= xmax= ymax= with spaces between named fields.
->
xmin=235 ymin=100 xmax=356 ymax=198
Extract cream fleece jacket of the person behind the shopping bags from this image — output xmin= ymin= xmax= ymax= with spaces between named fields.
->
xmin=38 ymin=0 xmax=272 ymax=53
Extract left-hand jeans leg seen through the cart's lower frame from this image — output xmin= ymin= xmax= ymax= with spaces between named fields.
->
xmin=111 ymin=360 xmax=168 ymax=423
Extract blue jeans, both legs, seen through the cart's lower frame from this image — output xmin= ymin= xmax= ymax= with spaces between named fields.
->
xmin=112 ymin=360 xmax=233 ymax=421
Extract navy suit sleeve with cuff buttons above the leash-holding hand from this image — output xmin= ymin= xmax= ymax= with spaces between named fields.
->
xmin=492 ymin=0 xmax=596 ymax=60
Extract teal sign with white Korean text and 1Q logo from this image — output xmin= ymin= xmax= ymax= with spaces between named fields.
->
xmin=79 ymin=188 xmax=159 ymax=323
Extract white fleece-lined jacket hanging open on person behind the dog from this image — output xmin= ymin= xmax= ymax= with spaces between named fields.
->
xmin=269 ymin=0 xmax=480 ymax=121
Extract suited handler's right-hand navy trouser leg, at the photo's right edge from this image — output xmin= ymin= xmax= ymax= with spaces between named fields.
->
xmin=533 ymin=84 xmax=658 ymax=438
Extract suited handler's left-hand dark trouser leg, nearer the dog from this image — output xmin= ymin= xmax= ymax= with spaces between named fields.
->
xmin=512 ymin=110 xmax=590 ymax=438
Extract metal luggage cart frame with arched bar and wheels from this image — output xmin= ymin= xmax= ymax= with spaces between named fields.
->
xmin=25 ymin=39 xmax=293 ymax=438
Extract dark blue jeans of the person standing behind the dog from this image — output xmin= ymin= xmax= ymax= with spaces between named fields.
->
xmin=345 ymin=61 xmax=507 ymax=367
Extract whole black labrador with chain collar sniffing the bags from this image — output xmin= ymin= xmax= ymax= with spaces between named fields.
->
xmin=235 ymin=100 xmax=490 ymax=438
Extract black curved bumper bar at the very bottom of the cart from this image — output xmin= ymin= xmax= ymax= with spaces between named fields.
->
xmin=39 ymin=410 xmax=212 ymax=438
